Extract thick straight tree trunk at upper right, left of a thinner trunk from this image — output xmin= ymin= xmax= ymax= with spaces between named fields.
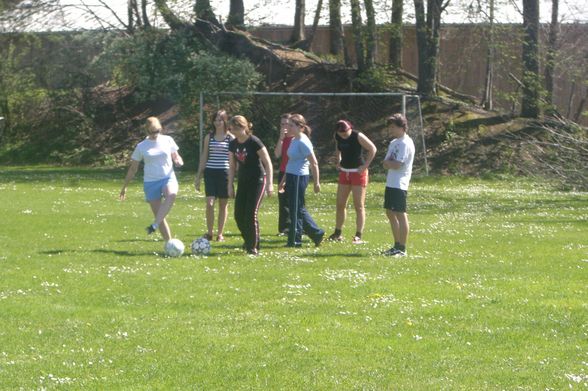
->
xmin=521 ymin=0 xmax=540 ymax=118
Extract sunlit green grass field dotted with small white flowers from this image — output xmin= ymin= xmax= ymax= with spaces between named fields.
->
xmin=0 ymin=168 xmax=588 ymax=390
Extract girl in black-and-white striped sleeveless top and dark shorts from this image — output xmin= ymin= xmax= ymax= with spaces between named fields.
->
xmin=194 ymin=110 xmax=235 ymax=242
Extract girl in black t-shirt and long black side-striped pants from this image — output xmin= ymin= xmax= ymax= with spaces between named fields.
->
xmin=228 ymin=115 xmax=273 ymax=255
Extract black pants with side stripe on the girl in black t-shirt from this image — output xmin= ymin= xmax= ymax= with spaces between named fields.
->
xmin=235 ymin=176 xmax=265 ymax=251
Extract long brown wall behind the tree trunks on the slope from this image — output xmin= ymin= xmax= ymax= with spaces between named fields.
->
xmin=252 ymin=24 xmax=588 ymax=125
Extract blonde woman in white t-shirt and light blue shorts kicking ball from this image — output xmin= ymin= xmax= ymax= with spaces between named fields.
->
xmin=120 ymin=117 xmax=184 ymax=241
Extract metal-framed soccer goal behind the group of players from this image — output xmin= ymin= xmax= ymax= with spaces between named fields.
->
xmin=199 ymin=92 xmax=428 ymax=175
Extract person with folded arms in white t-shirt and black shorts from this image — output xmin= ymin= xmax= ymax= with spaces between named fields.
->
xmin=383 ymin=114 xmax=414 ymax=257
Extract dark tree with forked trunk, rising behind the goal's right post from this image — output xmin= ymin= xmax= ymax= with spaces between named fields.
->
xmin=414 ymin=0 xmax=449 ymax=96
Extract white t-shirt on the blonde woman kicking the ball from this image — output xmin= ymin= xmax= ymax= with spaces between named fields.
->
xmin=131 ymin=134 xmax=180 ymax=182
